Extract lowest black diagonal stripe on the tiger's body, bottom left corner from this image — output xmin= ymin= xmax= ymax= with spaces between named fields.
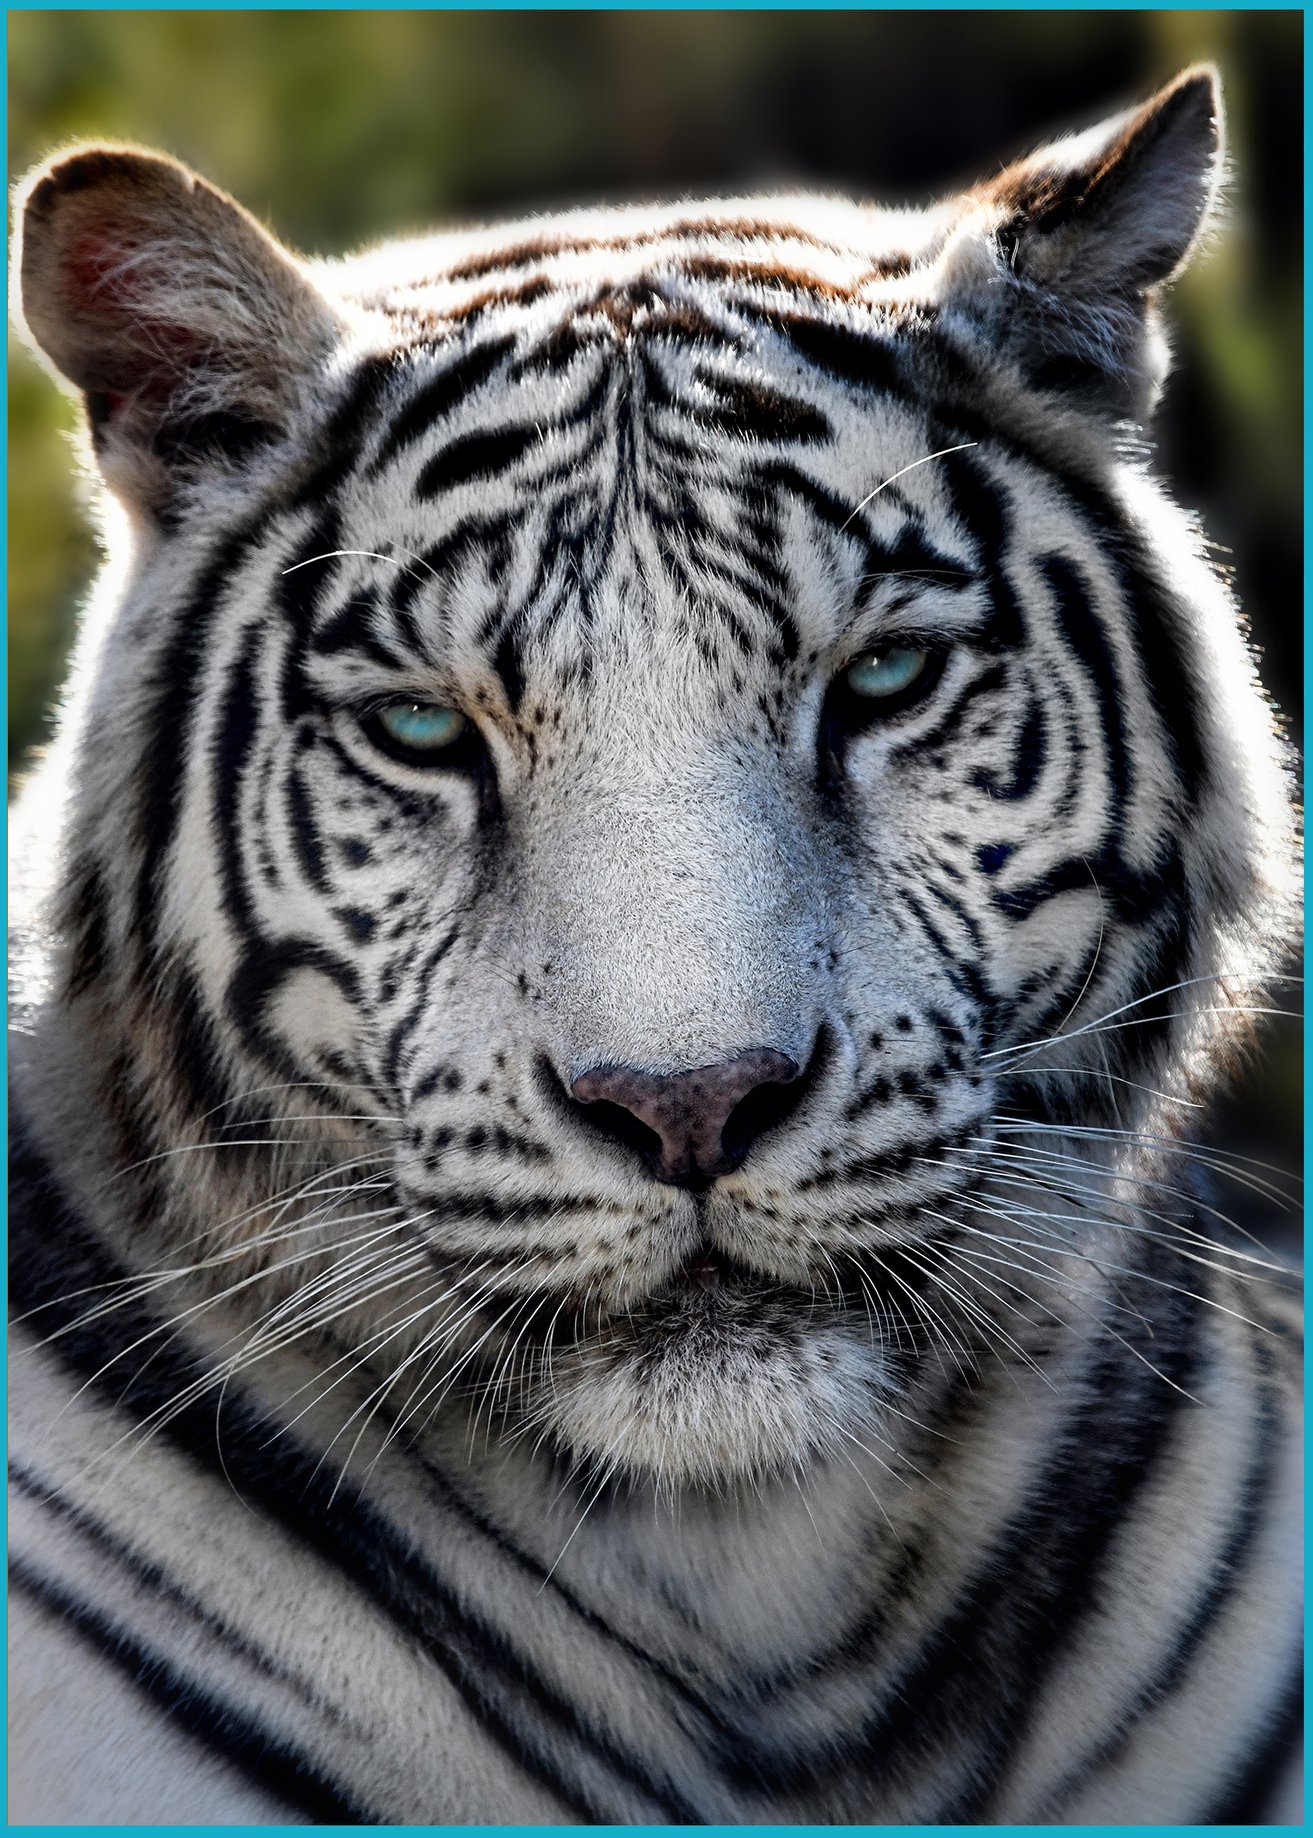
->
xmin=9 ymin=1559 xmax=367 ymax=1825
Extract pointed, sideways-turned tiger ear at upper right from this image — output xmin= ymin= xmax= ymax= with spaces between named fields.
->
xmin=975 ymin=66 xmax=1223 ymax=414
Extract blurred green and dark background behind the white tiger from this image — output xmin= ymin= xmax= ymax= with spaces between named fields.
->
xmin=9 ymin=11 xmax=1304 ymax=1176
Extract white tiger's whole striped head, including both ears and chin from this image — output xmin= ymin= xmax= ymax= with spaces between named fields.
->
xmin=17 ymin=72 xmax=1291 ymax=1487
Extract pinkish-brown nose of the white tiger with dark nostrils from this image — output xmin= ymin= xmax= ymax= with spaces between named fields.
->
xmin=570 ymin=1046 xmax=798 ymax=1189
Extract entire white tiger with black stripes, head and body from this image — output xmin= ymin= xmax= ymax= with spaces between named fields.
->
xmin=9 ymin=70 xmax=1300 ymax=1825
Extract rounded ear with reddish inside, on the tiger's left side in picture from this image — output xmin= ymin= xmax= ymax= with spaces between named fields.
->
xmin=13 ymin=145 xmax=340 ymax=516
